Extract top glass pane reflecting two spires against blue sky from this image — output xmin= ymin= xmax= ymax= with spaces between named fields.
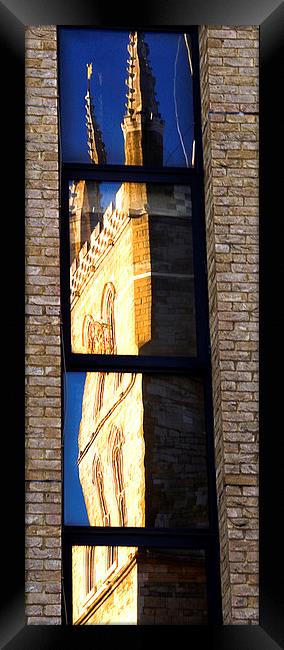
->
xmin=60 ymin=27 xmax=195 ymax=167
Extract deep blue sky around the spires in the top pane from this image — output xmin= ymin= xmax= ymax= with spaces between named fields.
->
xmin=60 ymin=27 xmax=194 ymax=166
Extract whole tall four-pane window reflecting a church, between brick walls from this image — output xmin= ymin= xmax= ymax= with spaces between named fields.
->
xmin=59 ymin=27 xmax=221 ymax=625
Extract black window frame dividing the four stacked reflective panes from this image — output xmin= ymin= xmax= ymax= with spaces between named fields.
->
xmin=60 ymin=25 xmax=222 ymax=625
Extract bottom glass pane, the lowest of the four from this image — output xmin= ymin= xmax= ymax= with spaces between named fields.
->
xmin=72 ymin=546 xmax=207 ymax=625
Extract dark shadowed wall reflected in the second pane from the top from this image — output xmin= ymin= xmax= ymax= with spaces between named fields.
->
xmin=139 ymin=184 xmax=196 ymax=356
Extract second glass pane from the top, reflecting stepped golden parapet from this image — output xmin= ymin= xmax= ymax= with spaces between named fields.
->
xmin=69 ymin=180 xmax=196 ymax=356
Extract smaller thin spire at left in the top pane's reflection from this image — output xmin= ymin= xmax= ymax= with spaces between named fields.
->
xmin=85 ymin=63 xmax=107 ymax=165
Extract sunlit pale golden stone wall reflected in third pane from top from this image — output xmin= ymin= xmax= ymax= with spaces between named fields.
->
xmin=79 ymin=373 xmax=145 ymax=526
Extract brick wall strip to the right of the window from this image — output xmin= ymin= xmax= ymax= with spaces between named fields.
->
xmin=200 ymin=26 xmax=258 ymax=624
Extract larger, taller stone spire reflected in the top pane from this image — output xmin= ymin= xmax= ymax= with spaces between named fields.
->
xmin=121 ymin=32 xmax=164 ymax=165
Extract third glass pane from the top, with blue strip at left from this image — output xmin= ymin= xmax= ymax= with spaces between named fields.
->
xmin=64 ymin=372 xmax=208 ymax=528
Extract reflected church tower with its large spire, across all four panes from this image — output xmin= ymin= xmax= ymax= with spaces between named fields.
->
xmin=71 ymin=33 xmax=207 ymax=624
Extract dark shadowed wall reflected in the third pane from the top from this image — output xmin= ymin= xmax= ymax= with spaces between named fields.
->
xmin=142 ymin=373 xmax=208 ymax=529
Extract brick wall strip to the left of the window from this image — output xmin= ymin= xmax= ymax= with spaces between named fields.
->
xmin=25 ymin=26 xmax=62 ymax=625
